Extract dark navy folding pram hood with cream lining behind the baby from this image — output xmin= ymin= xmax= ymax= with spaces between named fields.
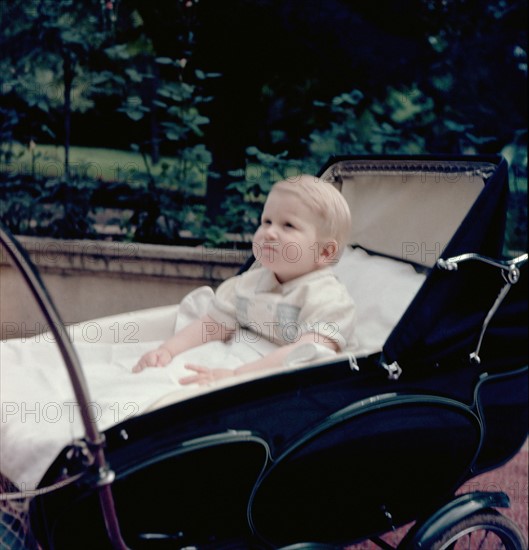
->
xmin=321 ymin=156 xmax=527 ymax=378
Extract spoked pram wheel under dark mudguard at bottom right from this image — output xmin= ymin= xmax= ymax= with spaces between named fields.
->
xmin=430 ymin=510 xmax=527 ymax=550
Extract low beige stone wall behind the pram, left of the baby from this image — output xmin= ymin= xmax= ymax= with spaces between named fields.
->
xmin=0 ymin=237 xmax=249 ymax=338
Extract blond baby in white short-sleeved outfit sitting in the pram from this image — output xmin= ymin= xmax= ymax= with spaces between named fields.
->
xmin=133 ymin=175 xmax=355 ymax=384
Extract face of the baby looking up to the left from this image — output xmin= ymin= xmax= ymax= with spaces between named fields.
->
xmin=253 ymin=191 xmax=321 ymax=283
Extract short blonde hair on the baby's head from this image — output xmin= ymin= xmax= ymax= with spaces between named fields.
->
xmin=270 ymin=174 xmax=351 ymax=257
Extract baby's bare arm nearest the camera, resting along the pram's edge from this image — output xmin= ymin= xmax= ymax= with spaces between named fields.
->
xmin=179 ymin=333 xmax=338 ymax=384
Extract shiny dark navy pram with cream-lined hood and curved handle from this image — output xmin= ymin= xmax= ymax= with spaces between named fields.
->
xmin=1 ymin=156 xmax=528 ymax=550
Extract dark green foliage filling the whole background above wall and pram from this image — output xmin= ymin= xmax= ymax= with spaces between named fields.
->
xmin=0 ymin=0 xmax=527 ymax=249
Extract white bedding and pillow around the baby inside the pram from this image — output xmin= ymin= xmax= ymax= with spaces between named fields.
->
xmin=0 ymin=249 xmax=424 ymax=490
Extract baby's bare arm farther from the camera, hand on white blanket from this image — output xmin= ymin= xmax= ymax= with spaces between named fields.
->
xmin=132 ymin=315 xmax=231 ymax=372
